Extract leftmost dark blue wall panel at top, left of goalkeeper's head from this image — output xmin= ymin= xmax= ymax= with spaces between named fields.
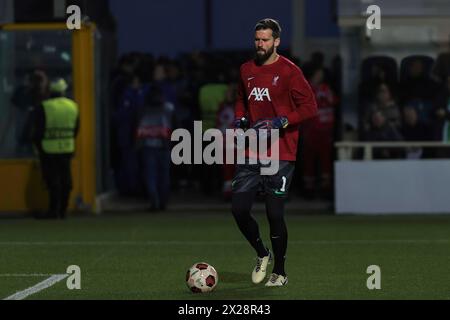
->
xmin=110 ymin=0 xmax=205 ymax=55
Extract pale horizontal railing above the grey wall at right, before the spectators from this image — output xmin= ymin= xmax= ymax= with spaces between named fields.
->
xmin=334 ymin=141 xmax=450 ymax=161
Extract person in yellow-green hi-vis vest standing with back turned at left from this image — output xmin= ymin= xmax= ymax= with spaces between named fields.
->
xmin=33 ymin=78 xmax=79 ymax=219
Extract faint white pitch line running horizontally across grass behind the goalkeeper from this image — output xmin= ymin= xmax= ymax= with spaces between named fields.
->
xmin=0 ymin=239 xmax=450 ymax=246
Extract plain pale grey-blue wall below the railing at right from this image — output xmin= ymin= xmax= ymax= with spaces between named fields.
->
xmin=335 ymin=160 xmax=450 ymax=214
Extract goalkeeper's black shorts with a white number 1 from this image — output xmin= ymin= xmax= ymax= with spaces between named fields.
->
xmin=232 ymin=161 xmax=295 ymax=198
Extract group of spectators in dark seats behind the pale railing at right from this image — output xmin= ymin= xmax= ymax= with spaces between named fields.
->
xmin=359 ymin=54 xmax=450 ymax=159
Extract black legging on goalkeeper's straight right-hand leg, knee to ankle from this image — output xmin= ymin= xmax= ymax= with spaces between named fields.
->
xmin=266 ymin=195 xmax=288 ymax=276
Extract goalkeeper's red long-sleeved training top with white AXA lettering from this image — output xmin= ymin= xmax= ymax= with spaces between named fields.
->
xmin=235 ymin=56 xmax=317 ymax=161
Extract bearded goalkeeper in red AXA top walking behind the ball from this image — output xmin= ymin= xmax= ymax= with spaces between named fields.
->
xmin=232 ymin=19 xmax=317 ymax=287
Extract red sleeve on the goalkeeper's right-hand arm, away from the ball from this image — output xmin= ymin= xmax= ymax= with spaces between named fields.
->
xmin=287 ymin=69 xmax=317 ymax=126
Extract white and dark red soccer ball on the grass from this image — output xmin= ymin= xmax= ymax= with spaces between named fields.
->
xmin=186 ymin=262 xmax=219 ymax=293
